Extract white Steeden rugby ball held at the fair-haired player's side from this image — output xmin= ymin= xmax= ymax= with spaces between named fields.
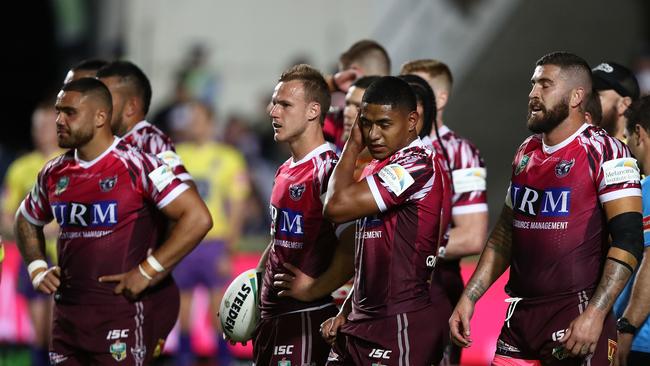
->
xmin=219 ymin=269 xmax=262 ymax=342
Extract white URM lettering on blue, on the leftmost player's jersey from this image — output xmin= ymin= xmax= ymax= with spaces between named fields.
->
xmin=52 ymin=201 xmax=117 ymax=227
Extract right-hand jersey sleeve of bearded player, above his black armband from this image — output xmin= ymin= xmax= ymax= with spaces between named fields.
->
xmin=589 ymin=136 xmax=641 ymax=203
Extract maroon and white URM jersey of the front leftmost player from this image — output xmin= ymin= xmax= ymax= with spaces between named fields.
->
xmin=20 ymin=138 xmax=188 ymax=304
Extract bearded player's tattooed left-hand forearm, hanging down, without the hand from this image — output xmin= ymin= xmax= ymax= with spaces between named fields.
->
xmin=463 ymin=205 xmax=512 ymax=303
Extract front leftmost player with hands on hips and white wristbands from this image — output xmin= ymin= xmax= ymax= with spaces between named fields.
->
xmin=15 ymin=78 xmax=212 ymax=365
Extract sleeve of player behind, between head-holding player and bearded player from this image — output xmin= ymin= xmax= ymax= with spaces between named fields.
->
xmin=451 ymin=141 xmax=488 ymax=215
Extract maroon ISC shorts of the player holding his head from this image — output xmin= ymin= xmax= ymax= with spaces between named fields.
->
xmin=327 ymin=305 xmax=449 ymax=366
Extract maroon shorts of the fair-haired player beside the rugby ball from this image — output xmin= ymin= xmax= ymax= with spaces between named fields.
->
xmin=253 ymin=304 xmax=338 ymax=366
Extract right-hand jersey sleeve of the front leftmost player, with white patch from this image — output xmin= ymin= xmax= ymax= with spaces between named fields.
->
xmin=139 ymin=154 xmax=189 ymax=209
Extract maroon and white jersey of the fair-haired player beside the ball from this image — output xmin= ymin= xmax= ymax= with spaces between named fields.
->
xmin=261 ymin=144 xmax=338 ymax=318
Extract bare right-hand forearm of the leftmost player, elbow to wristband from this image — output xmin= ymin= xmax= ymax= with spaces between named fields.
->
xmin=148 ymin=207 xmax=212 ymax=272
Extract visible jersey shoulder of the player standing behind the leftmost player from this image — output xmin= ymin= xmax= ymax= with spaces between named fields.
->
xmin=122 ymin=120 xmax=192 ymax=182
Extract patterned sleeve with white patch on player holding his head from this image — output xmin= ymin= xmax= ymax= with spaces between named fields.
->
xmin=366 ymin=148 xmax=436 ymax=212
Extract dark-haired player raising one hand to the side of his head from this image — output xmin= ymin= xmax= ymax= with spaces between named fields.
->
xmin=322 ymin=77 xmax=451 ymax=365
